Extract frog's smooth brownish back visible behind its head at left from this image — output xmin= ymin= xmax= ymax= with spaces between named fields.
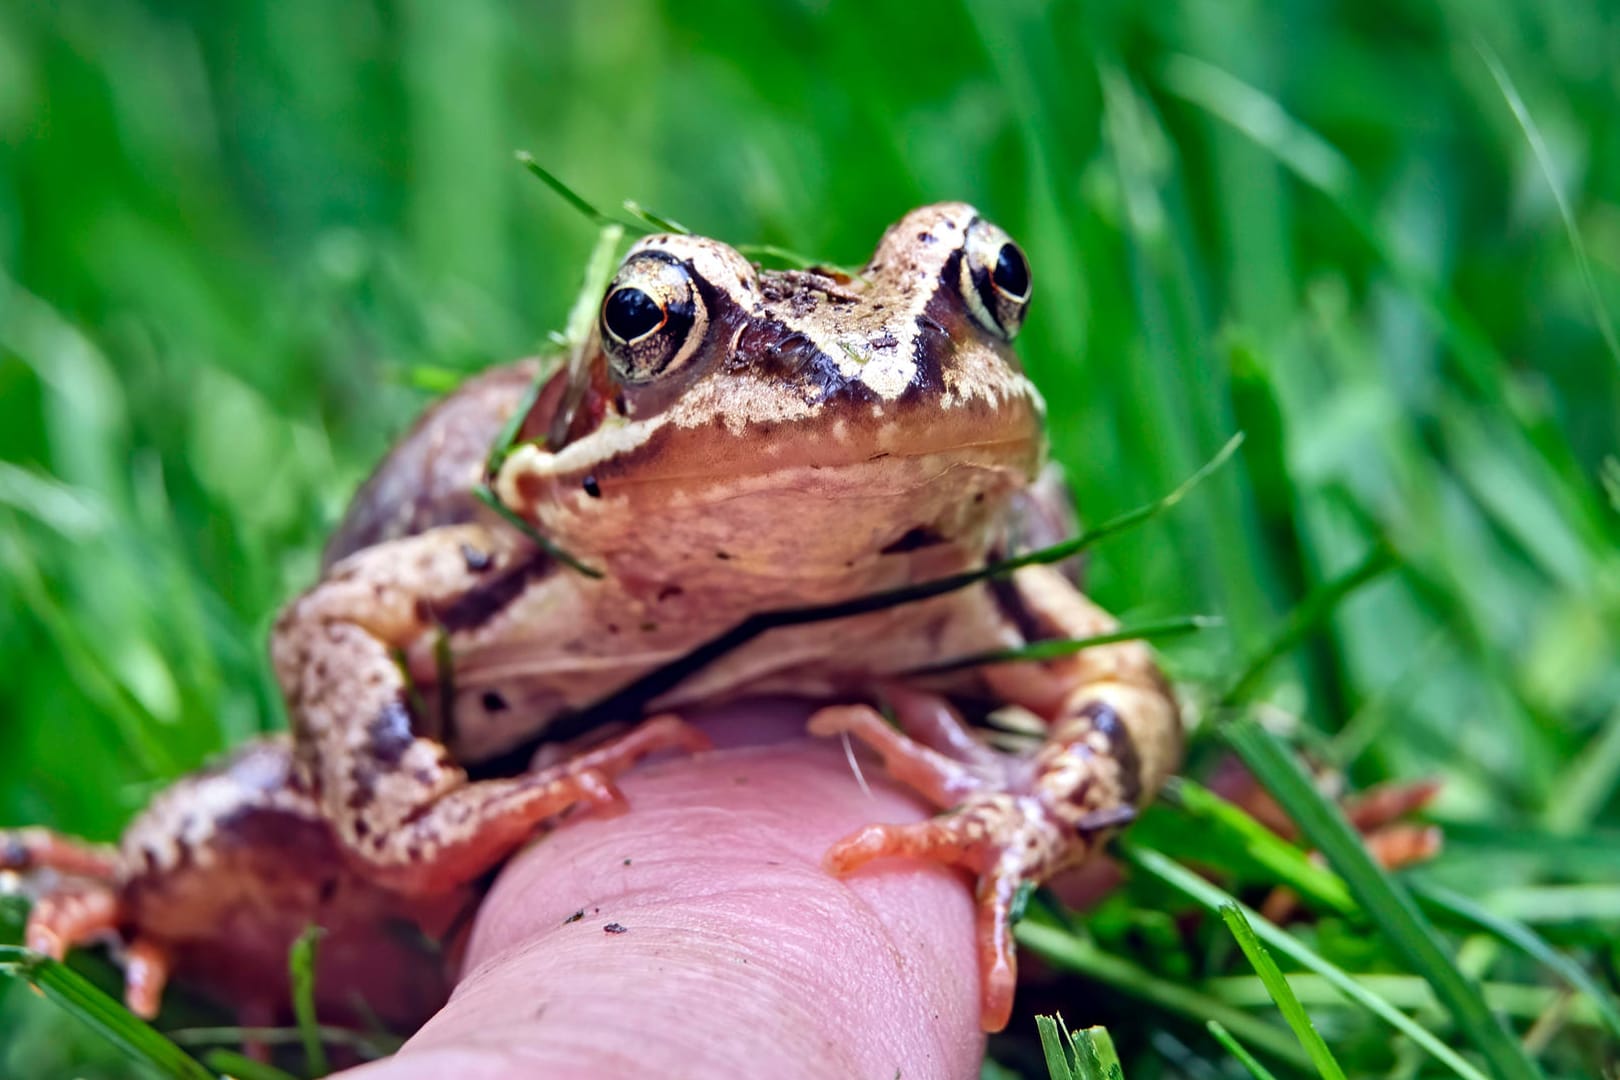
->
xmin=321 ymin=358 xmax=541 ymax=568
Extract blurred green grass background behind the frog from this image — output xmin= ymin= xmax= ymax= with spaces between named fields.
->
xmin=0 ymin=0 xmax=1620 ymax=1075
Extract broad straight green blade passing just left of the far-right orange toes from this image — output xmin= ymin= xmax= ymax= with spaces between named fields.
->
xmin=1221 ymin=717 xmax=1541 ymax=1080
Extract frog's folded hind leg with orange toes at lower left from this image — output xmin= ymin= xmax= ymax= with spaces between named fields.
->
xmin=0 ymin=738 xmax=475 ymax=1028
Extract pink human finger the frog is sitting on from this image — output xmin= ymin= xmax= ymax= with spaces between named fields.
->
xmin=345 ymin=706 xmax=983 ymax=1080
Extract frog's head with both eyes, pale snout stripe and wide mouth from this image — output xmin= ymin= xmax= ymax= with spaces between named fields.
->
xmin=496 ymin=202 xmax=1045 ymax=586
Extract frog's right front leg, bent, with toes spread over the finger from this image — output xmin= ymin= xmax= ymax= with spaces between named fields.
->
xmin=810 ymin=567 xmax=1181 ymax=1031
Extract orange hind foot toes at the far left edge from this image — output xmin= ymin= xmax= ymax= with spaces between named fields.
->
xmin=0 ymin=829 xmax=170 ymax=1020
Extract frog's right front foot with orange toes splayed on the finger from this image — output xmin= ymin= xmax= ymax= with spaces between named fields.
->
xmin=810 ymin=688 xmax=1137 ymax=1031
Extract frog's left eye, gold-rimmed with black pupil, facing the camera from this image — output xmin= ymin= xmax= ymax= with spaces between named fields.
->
xmin=601 ymin=251 xmax=708 ymax=382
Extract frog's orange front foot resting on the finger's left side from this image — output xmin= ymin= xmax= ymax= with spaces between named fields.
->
xmin=339 ymin=716 xmax=710 ymax=895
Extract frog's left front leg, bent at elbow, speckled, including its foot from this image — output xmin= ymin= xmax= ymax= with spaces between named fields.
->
xmin=272 ymin=525 xmax=708 ymax=894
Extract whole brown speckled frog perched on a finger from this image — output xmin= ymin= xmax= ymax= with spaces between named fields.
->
xmin=5 ymin=202 xmax=1179 ymax=1030
